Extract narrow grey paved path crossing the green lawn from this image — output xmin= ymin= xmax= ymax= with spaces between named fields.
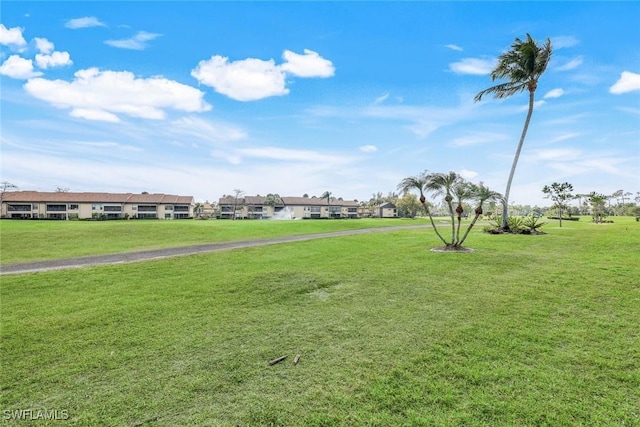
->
xmin=0 ymin=225 xmax=431 ymax=275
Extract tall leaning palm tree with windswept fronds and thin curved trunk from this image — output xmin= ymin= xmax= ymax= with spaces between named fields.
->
xmin=474 ymin=34 xmax=553 ymax=230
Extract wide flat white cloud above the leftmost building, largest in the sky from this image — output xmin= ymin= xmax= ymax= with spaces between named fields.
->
xmin=24 ymin=68 xmax=211 ymax=121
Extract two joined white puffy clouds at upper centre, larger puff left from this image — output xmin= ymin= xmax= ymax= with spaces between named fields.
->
xmin=191 ymin=49 xmax=334 ymax=101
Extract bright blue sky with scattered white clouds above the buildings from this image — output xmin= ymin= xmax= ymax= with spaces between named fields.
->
xmin=0 ymin=1 xmax=640 ymax=206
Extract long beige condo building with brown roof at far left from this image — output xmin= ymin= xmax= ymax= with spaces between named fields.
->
xmin=0 ymin=191 xmax=195 ymax=220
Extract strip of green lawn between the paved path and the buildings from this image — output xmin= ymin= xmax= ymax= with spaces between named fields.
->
xmin=0 ymin=219 xmax=418 ymax=264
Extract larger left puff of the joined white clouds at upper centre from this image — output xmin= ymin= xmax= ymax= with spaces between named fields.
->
xmin=191 ymin=55 xmax=289 ymax=101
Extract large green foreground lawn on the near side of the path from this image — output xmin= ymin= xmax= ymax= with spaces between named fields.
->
xmin=0 ymin=218 xmax=640 ymax=426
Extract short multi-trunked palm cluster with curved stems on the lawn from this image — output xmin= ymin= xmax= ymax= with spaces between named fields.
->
xmin=398 ymin=171 xmax=502 ymax=250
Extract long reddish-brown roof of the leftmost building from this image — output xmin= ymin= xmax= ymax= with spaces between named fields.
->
xmin=2 ymin=191 xmax=193 ymax=205
